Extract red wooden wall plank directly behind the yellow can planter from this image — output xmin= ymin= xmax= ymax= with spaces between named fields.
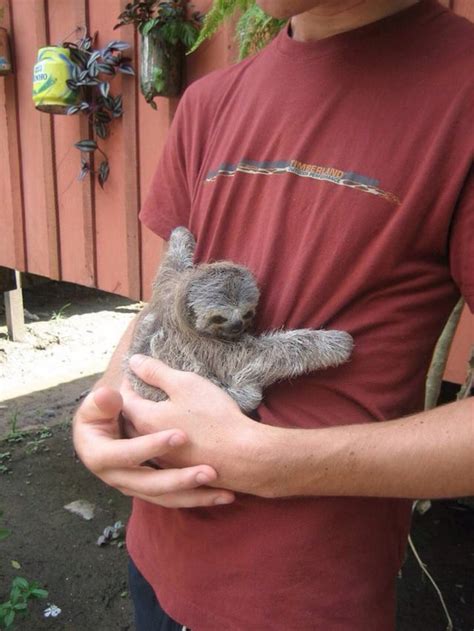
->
xmin=48 ymin=0 xmax=95 ymax=286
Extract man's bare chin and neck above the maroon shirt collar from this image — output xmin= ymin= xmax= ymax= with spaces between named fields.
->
xmin=291 ymin=0 xmax=418 ymax=42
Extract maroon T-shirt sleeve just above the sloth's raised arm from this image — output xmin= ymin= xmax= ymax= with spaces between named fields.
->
xmin=139 ymin=91 xmax=192 ymax=240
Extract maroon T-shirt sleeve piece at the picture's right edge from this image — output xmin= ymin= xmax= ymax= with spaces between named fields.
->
xmin=449 ymin=167 xmax=474 ymax=313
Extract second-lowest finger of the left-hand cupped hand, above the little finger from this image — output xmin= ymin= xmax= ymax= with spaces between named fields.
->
xmin=106 ymin=465 xmax=217 ymax=497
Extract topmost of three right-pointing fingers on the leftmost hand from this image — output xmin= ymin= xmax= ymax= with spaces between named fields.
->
xmin=85 ymin=429 xmax=187 ymax=471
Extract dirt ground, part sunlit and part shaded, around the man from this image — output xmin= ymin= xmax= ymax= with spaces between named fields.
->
xmin=0 ymin=282 xmax=474 ymax=631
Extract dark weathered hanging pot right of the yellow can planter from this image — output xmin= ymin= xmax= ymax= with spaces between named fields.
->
xmin=140 ymin=31 xmax=184 ymax=105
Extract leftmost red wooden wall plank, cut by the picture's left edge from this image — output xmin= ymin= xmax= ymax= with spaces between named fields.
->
xmin=0 ymin=0 xmax=26 ymax=270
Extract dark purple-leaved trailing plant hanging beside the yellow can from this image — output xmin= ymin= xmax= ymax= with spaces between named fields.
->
xmin=63 ymin=34 xmax=135 ymax=188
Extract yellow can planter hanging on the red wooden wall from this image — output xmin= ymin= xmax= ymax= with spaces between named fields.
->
xmin=33 ymin=46 xmax=79 ymax=114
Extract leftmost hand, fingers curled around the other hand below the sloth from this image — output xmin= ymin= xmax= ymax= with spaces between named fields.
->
xmin=73 ymin=387 xmax=234 ymax=508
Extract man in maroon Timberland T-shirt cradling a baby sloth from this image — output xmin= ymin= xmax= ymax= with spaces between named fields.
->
xmin=74 ymin=0 xmax=474 ymax=631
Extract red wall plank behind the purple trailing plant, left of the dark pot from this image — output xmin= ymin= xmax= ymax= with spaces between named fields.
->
xmin=89 ymin=0 xmax=139 ymax=297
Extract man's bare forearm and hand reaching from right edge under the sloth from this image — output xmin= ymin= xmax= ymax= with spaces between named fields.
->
xmin=125 ymin=358 xmax=474 ymax=499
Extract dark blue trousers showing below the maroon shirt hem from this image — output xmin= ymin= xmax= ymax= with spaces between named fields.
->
xmin=128 ymin=559 xmax=189 ymax=631
